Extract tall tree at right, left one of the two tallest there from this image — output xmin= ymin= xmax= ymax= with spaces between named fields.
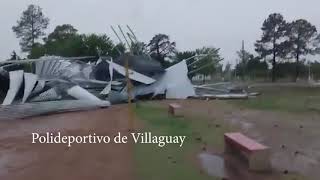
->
xmin=255 ymin=13 xmax=288 ymax=82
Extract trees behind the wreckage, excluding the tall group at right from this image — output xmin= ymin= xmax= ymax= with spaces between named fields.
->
xmin=11 ymin=5 xmax=221 ymax=74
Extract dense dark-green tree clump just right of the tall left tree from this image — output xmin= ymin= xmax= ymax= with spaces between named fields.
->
xmin=29 ymin=24 xmax=117 ymax=58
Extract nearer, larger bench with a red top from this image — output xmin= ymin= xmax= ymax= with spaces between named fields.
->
xmin=224 ymin=133 xmax=271 ymax=171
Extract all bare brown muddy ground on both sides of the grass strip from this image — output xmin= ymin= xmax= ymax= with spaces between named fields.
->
xmin=0 ymin=100 xmax=320 ymax=180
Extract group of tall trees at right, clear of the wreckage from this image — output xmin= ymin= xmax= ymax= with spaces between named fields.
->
xmin=229 ymin=13 xmax=320 ymax=82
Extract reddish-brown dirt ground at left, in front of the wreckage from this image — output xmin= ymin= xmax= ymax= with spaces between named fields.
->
xmin=0 ymin=105 xmax=133 ymax=180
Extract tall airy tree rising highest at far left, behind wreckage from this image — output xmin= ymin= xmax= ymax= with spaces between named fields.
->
xmin=12 ymin=5 xmax=49 ymax=52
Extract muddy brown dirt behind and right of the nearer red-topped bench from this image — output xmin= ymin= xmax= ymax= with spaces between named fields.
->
xmin=163 ymin=100 xmax=320 ymax=180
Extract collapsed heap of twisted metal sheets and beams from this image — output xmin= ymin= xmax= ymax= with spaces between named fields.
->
xmin=0 ymin=26 xmax=256 ymax=119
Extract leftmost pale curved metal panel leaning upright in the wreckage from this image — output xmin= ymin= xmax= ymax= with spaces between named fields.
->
xmin=2 ymin=70 xmax=23 ymax=105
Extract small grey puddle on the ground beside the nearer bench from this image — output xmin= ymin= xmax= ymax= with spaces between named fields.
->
xmin=199 ymin=153 xmax=226 ymax=178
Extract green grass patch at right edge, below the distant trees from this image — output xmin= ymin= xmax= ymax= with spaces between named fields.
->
xmin=229 ymin=87 xmax=320 ymax=113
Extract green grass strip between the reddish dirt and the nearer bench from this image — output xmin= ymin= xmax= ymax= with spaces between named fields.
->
xmin=134 ymin=103 xmax=230 ymax=180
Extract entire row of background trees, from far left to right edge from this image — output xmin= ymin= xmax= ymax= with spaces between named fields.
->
xmin=11 ymin=5 xmax=320 ymax=81
